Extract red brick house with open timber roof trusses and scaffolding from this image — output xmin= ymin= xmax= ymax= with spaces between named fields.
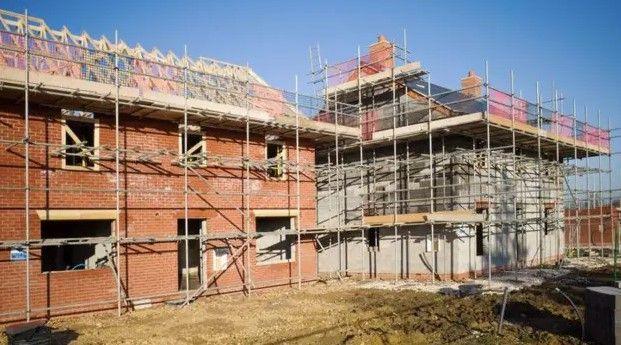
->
xmin=0 ymin=11 xmax=356 ymax=319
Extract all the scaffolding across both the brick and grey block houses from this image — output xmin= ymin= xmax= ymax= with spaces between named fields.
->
xmin=0 ymin=10 xmax=619 ymax=320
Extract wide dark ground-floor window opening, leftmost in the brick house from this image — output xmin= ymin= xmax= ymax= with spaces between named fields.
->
xmin=41 ymin=220 xmax=112 ymax=272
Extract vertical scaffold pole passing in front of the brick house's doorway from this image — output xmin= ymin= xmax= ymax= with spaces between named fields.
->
xmin=183 ymin=46 xmax=190 ymax=304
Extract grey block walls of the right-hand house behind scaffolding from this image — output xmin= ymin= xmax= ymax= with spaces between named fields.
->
xmin=317 ymin=136 xmax=564 ymax=279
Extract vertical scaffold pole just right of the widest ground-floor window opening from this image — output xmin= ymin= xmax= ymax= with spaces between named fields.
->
xmin=114 ymin=30 xmax=121 ymax=316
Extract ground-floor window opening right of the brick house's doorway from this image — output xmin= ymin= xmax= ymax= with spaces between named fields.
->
xmin=257 ymin=217 xmax=294 ymax=264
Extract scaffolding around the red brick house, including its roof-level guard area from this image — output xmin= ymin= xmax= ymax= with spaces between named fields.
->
xmin=0 ymin=11 xmax=358 ymax=320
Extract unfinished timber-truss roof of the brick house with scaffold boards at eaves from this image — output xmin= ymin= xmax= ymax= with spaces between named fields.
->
xmin=0 ymin=10 xmax=359 ymax=142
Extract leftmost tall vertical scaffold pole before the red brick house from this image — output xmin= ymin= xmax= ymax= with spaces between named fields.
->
xmin=24 ymin=10 xmax=30 ymax=321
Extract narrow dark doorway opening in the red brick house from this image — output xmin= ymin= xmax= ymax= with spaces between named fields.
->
xmin=177 ymin=219 xmax=204 ymax=290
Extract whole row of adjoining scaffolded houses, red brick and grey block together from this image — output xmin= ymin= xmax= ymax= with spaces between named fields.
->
xmin=0 ymin=10 xmax=616 ymax=320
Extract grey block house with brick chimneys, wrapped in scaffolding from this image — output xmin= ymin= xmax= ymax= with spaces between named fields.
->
xmin=316 ymin=36 xmax=612 ymax=281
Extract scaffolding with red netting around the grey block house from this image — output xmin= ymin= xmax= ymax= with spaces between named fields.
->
xmin=311 ymin=37 xmax=619 ymax=284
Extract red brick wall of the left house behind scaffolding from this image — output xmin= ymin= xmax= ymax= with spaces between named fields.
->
xmin=0 ymin=101 xmax=317 ymax=319
